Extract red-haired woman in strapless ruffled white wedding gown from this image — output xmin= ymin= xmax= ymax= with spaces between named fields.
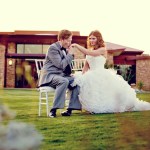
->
xmin=71 ymin=30 xmax=150 ymax=113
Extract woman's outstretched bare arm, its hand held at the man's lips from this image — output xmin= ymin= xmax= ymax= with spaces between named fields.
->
xmin=71 ymin=44 xmax=107 ymax=57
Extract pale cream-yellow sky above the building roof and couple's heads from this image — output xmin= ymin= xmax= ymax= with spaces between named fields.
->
xmin=0 ymin=0 xmax=150 ymax=54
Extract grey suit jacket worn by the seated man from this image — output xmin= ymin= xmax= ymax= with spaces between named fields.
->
xmin=38 ymin=42 xmax=74 ymax=86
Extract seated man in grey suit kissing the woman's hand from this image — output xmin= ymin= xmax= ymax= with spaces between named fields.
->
xmin=39 ymin=30 xmax=81 ymax=118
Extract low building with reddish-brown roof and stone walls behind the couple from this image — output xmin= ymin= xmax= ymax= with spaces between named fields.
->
xmin=0 ymin=31 xmax=150 ymax=90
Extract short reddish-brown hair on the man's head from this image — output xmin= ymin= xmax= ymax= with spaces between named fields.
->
xmin=57 ymin=30 xmax=72 ymax=41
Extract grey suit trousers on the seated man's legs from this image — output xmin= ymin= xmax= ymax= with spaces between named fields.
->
xmin=49 ymin=75 xmax=81 ymax=110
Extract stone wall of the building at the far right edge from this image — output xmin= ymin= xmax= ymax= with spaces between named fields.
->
xmin=136 ymin=55 xmax=150 ymax=91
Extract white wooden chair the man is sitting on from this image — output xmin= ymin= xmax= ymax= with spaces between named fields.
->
xmin=35 ymin=59 xmax=55 ymax=116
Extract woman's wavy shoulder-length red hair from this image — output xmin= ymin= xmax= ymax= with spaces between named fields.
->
xmin=87 ymin=30 xmax=105 ymax=49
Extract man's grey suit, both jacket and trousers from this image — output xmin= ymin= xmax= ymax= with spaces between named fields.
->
xmin=39 ymin=42 xmax=81 ymax=110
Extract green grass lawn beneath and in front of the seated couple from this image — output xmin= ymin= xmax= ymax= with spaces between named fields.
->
xmin=0 ymin=89 xmax=150 ymax=150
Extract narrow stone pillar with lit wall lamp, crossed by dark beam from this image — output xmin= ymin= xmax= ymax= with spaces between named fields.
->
xmin=6 ymin=43 xmax=16 ymax=88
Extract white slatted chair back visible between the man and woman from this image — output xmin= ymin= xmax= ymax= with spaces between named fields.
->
xmin=72 ymin=59 xmax=85 ymax=71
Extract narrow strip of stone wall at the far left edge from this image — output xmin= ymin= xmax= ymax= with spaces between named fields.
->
xmin=0 ymin=44 xmax=6 ymax=88
